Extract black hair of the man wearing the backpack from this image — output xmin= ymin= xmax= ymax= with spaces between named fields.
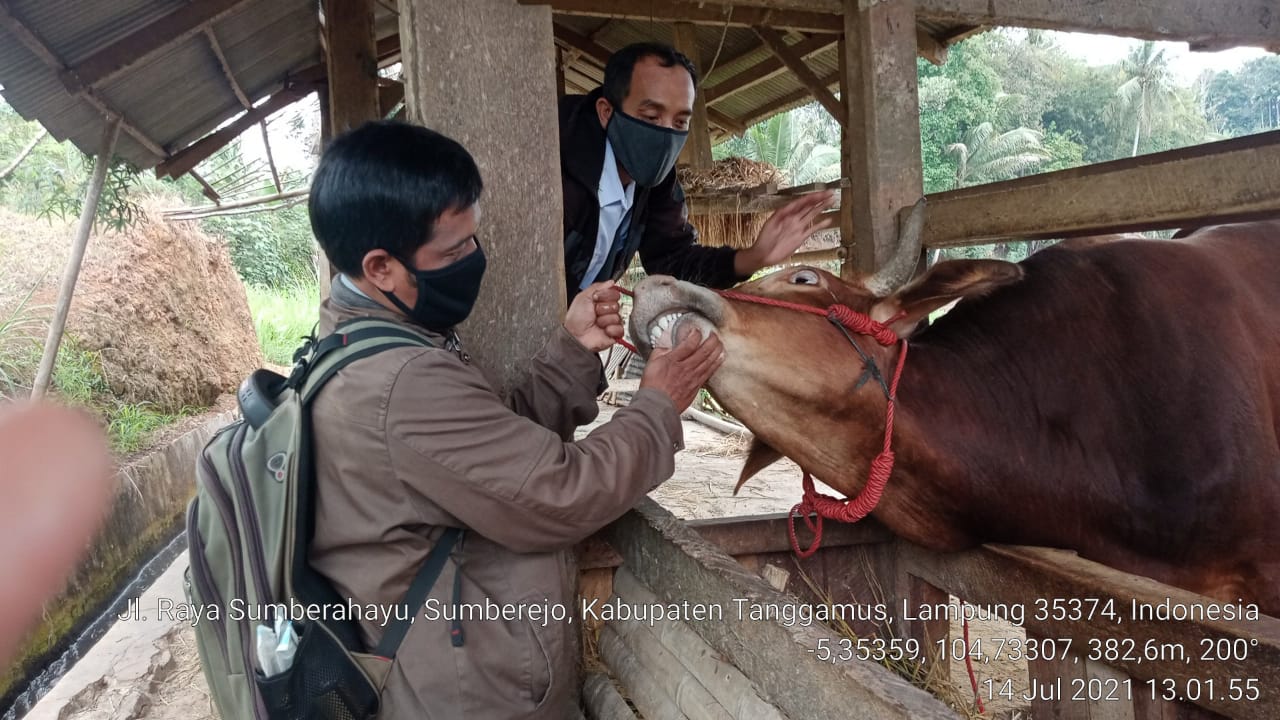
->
xmin=307 ymin=120 xmax=484 ymax=272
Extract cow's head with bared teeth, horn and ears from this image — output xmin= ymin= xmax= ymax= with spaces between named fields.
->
xmin=631 ymin=201 xmax=1021 ymax=496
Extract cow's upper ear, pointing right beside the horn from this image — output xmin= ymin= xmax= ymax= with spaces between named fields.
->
xmin=872 ymin=260 xmax=1023 ymax=337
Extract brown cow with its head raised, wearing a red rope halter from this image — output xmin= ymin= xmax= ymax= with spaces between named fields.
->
xmin=631 ymin=213 xmax=1280 ymax=615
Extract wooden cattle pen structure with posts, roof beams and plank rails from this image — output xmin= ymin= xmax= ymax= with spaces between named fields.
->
xmin=0 ymin=0 xmax=1280 ymax=720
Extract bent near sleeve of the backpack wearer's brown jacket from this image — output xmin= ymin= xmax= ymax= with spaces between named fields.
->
xmin=387 ymin=352 xmax=684 ymax=552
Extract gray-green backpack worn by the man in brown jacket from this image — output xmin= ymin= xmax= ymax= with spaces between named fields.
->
xmin=186 ymin=318 xmax=461 ymax=720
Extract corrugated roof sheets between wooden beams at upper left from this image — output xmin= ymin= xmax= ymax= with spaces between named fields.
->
xmin=0 ymin=0 xmax=398 ymax=168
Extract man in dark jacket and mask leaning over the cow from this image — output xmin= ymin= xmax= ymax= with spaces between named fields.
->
xmin=559 ymin=42 xmax=835 ymax=300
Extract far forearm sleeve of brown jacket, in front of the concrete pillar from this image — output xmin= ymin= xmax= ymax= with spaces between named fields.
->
xmin=507 ymin=325 xmax=600 ymax=441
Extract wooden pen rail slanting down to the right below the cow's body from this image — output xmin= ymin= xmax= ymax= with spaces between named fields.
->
xmin=899 ymin=543 xmax=1280 ymax=719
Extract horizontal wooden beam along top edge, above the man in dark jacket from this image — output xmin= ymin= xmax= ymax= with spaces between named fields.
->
xmin=518 ymin=0 xmax=841 ymax=33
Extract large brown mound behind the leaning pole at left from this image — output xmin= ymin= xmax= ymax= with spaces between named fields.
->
xmin=0 ymin=202 xmax=262 ymax=413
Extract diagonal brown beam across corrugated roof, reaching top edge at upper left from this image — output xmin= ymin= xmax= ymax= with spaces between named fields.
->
xmin=63 ymin=0 xmax=248 ymax=92
